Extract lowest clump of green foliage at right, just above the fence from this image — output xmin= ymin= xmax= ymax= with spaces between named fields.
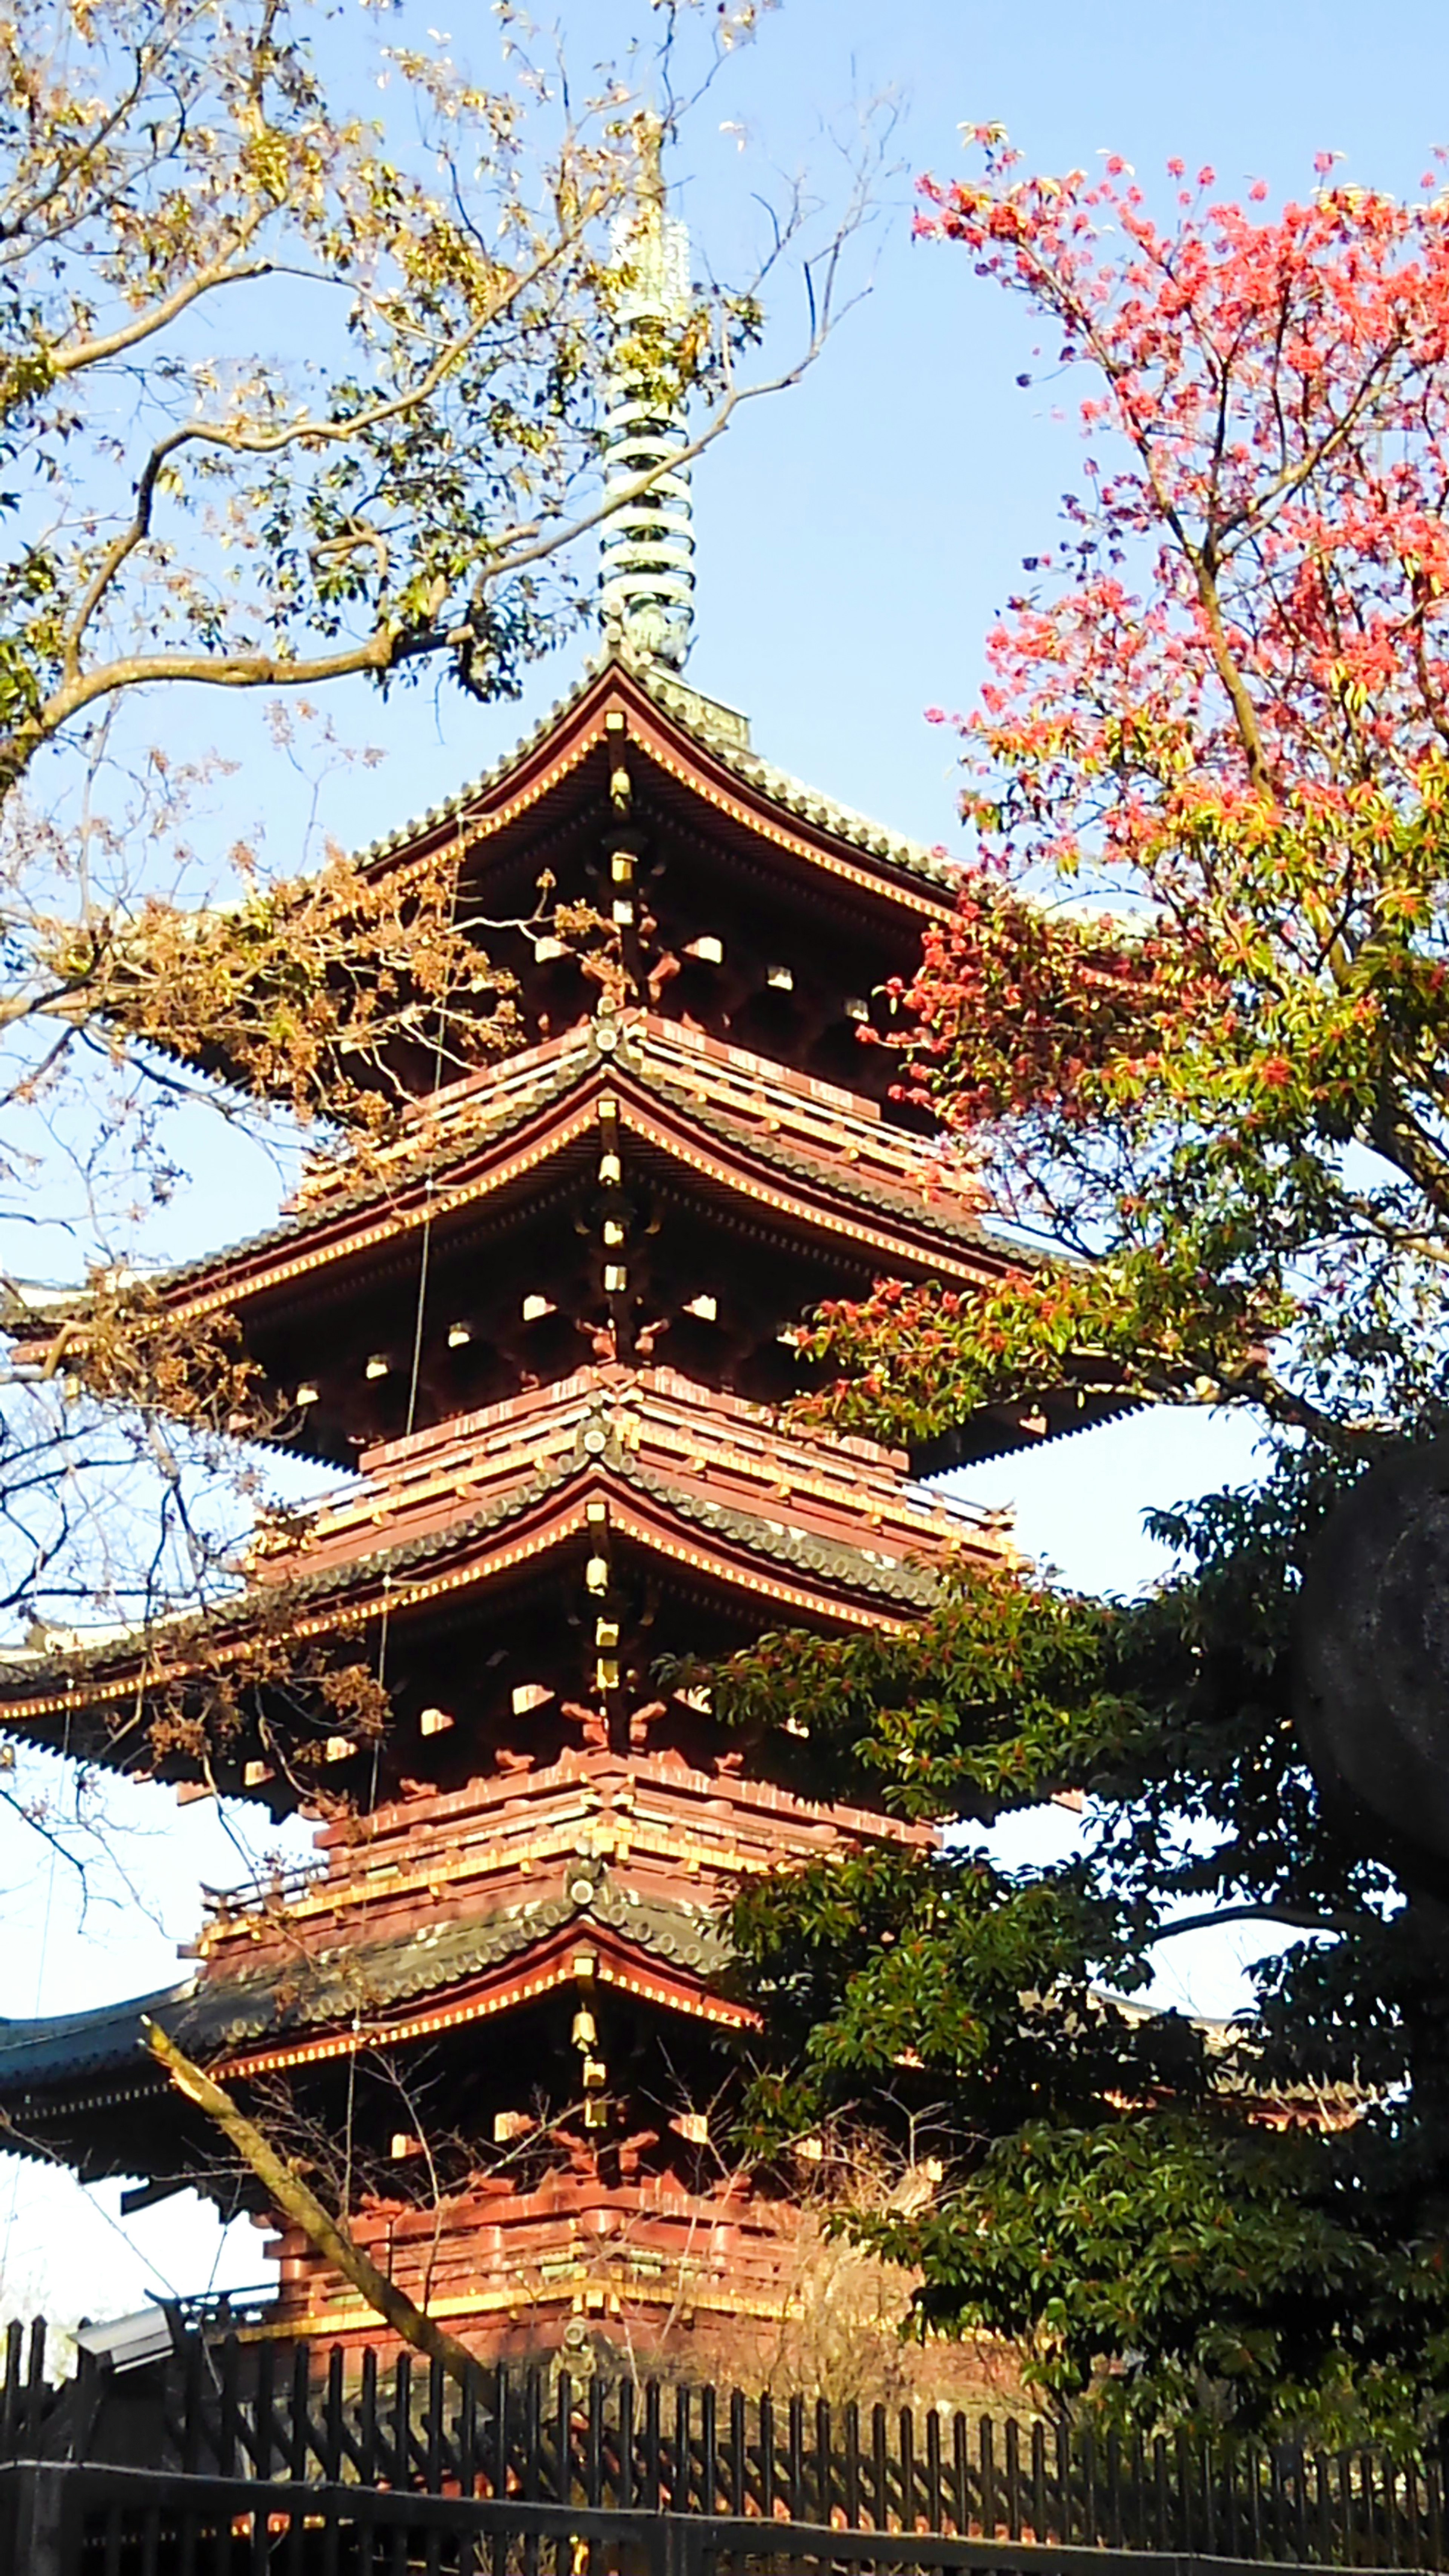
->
xmin=881 ymin=2105 xmax=1449 ymax=2445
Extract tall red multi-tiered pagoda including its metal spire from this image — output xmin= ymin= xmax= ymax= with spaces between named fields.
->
xmin=0 ymin=181 xmax=1093 ymax=2352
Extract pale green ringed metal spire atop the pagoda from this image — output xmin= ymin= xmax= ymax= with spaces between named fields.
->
xmin=601 ymin=116 xmax=694 ymax=670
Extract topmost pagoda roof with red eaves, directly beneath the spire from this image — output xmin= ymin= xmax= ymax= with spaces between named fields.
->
xmin=356 ymin=641 xmax=959 ymax=915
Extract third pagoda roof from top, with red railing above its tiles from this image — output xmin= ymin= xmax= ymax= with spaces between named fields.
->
xmin=0 ymin=1368 xmax=1000 ymax=1770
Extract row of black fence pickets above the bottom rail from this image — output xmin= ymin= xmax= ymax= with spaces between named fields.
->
xmin=0 ymin=2326 xmax=1446 ymax=2568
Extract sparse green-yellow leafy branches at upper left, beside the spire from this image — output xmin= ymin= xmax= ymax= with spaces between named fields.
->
xmin=0 ymin=0 xmax=830 ymax=788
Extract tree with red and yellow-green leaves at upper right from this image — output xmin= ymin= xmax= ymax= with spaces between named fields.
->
xmin=823 ymin=129 xmax=1449 ymax=1440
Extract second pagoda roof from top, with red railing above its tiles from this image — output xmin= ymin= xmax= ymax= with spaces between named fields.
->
xmin=8 ymin=1012 xmax=1132 ymax=1468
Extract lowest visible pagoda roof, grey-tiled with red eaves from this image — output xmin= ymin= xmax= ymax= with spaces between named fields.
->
xmin=0 ymin=1875 xmax=753 ymax=2151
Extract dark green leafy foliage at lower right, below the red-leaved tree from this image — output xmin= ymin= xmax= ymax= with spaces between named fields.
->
xmin=732 ymin=1450 xmax=1449 ymax=2439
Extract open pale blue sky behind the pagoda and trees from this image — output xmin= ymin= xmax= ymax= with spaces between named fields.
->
xmin=0 ymin=0 xmax=1423 ymax=2316
